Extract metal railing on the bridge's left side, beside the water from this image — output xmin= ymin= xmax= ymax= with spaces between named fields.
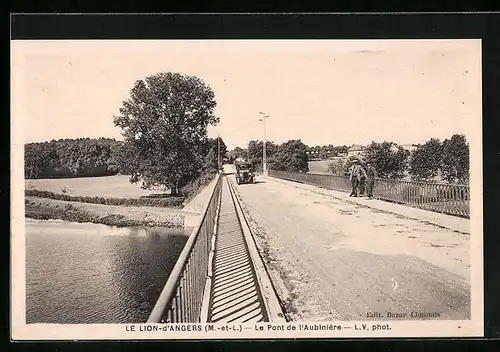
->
xmin=147 ymin=173 xmax=222 ymax=323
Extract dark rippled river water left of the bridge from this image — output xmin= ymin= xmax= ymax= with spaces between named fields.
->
xmin=26 ymin=220 xmax=189 ymax=324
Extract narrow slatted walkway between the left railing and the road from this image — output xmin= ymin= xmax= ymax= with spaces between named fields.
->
xmin=208 ymin=177 xmax=269 ymax=323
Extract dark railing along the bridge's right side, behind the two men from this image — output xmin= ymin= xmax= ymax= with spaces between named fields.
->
xmin=269 ymin=170 xmax=470 ymax=218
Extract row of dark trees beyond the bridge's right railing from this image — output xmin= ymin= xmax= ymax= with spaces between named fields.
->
xmin=228 ymin=134 xmax=469 ymax=183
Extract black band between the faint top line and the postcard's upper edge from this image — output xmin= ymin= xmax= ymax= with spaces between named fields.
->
xmin=6 ymin=13 xmax=500 ymax=40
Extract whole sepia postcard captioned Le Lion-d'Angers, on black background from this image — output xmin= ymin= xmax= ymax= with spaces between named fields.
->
xmin=11 ymin=39 xmax=484 ymax=341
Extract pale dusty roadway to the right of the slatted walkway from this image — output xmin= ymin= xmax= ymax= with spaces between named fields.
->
xmin=227 ymin=165 xmax=470 ymax=321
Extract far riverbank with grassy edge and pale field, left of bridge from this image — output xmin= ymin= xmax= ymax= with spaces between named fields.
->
xmin=25 ymin=174 xmax=217 ymax=228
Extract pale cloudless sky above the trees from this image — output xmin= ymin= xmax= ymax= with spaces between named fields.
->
xmin=11 ymin=40 xmax=481 ymax=149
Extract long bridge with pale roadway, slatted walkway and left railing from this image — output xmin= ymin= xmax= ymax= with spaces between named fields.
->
xmin=148 ymin=165 xmax=470 ymax=323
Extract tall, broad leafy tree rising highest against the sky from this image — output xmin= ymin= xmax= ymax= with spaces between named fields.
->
xmin=114 ymin=72 xmax=219 ymax=195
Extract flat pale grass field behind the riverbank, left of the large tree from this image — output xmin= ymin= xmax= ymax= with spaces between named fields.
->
xmin=25 ymin=175 xmax=165 ymax=198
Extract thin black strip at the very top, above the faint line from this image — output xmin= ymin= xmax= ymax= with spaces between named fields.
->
xmin=5 ymin=0 xmax=500 ymax=13
